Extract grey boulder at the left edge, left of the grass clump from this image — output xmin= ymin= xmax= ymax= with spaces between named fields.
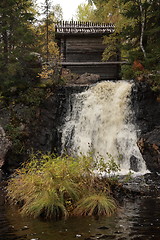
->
xmin=0 ymin=126 xmax=11 ymax=179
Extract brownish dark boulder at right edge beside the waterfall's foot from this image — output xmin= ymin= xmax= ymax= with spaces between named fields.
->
xmin=138 ymin=126 xmax=160 ymax=173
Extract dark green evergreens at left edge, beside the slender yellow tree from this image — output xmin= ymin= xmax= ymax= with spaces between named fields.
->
xmin=0 ymin=0 xmax=36 ymax=91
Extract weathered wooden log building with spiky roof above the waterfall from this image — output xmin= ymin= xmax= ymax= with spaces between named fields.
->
xmin=55 ymin=21 xmax=124 ymax=80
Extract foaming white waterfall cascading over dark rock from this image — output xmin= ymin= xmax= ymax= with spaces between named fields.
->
xmin=62 ymin=81 xmax=146 ymax=174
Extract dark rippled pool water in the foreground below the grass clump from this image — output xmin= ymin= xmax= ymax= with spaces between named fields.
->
xmin=0 ymin=188 xmax=160 ymax=240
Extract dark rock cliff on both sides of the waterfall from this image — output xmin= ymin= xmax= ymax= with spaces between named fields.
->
xmin=0 ymin=82 xmax=160 ymax=172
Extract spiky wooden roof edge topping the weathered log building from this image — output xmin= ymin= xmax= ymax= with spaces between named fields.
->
xmin=55 ymin=21 xmax=114 ymax=33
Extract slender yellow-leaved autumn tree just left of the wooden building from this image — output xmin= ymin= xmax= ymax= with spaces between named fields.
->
xmin=37 ymin=0 xmax=63 ymax=85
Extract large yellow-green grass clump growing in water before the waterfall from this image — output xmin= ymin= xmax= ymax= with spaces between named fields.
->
xmin=7 ymin=154 xmax=117 ymax=219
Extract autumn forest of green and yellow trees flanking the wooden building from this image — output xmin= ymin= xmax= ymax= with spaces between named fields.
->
xmin=0 ymin=0 xmax=160 ymax=95
